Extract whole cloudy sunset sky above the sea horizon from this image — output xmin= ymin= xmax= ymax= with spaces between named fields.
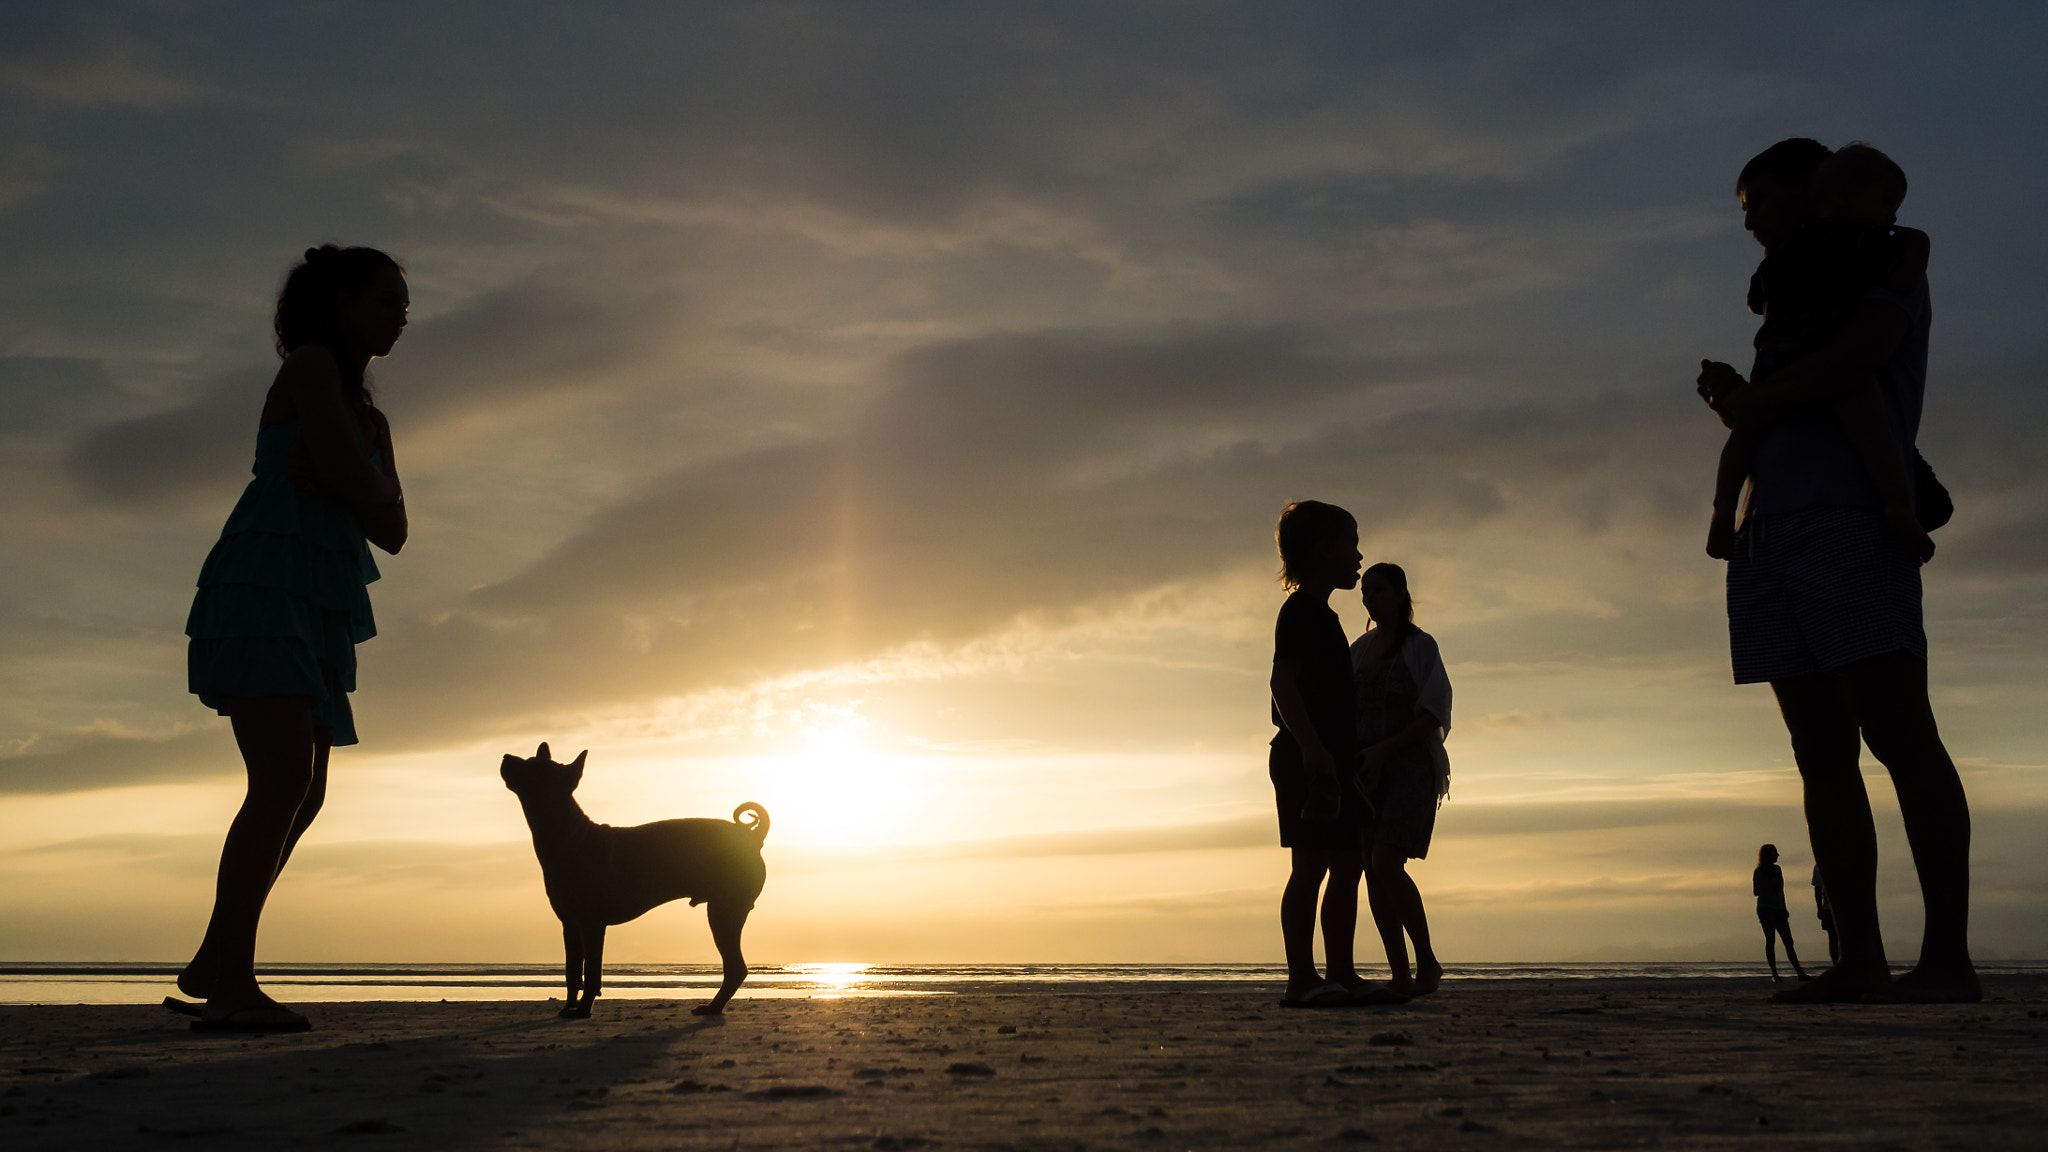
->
xmin=0 ymin=0 xmax=2048 ymax=965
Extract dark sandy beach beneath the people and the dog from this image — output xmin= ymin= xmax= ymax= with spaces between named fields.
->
xmin=0 ymin=976 xmax=2048 ymax=1150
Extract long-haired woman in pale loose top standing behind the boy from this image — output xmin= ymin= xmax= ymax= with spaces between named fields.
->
xmin=1352 ymin=564 xmax=1450 ymax=996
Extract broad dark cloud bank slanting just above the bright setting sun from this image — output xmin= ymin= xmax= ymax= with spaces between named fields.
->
xmin=339 ymin=319 xmax=1657 ymax=746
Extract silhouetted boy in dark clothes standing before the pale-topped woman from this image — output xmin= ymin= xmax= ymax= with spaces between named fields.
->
xmin=1268 ymin=500 xmax=1366 ymax=1009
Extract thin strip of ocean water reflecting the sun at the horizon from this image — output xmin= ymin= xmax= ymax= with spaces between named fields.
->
xmin=0 ymin=961 xmax=2048 ymax=1004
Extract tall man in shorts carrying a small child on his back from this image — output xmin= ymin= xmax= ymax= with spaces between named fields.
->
xmin=1698 ymin=139 xmax=1982 ymax=1002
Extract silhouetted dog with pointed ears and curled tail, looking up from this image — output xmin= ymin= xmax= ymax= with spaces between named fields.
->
xmin=498 ymin=744 xmax=768 ymax=1019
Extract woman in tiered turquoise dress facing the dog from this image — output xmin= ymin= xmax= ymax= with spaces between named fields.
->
xmin=178 ymin=244 xmax=410 ymax=1031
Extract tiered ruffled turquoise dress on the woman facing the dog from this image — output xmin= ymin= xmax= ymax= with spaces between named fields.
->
xmin=184 ymin=420 xmax=379 ymax=746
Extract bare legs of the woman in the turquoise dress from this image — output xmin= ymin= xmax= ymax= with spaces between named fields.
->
xmin=178 ymin=697 xmax=326 ymax=1019
